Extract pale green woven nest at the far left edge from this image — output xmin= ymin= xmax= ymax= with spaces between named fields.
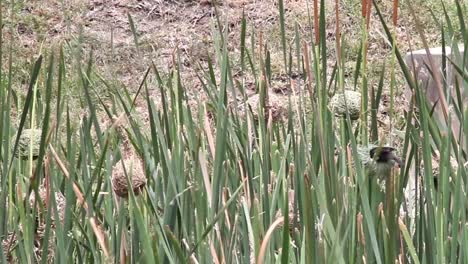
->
xmin=11 ymin=129 xmax=42 ymax=160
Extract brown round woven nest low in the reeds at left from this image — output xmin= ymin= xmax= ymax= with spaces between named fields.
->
xmin=112 ymin=157 xmax=146 ymax=198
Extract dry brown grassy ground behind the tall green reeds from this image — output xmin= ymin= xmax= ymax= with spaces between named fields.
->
xmin=2 ymin=0 xmax=460 ymax=144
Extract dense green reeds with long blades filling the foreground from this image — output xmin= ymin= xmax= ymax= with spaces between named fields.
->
xmin=0 ymin=0 xmax=468 ymax=263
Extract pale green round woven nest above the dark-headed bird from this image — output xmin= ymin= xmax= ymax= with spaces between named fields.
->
xmin=330 ymin=90 xmax=361 ymax=120
